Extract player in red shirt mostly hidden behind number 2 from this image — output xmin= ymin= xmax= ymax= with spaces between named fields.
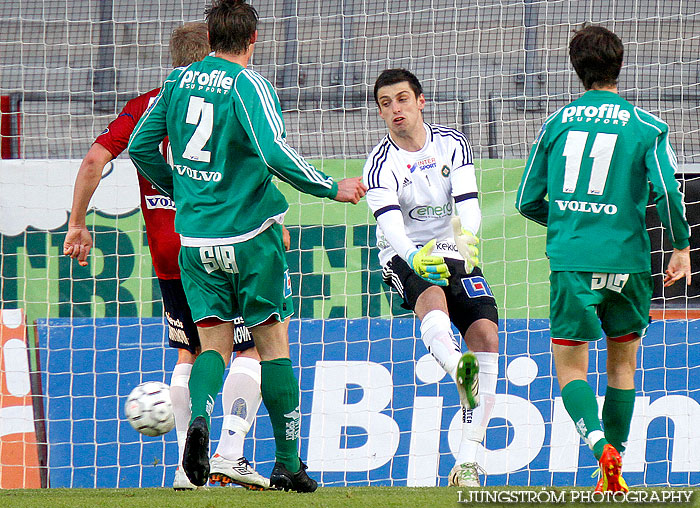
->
xmin=63 ymin=23 xmax=272 ymax=490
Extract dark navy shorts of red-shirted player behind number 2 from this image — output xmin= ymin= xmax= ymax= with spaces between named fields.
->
xmin=158 ymin=279 xmax=254 ymax=355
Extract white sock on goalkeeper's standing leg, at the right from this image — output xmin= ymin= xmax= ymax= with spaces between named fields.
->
xmin=456 ymin=352 xmax=498 ymax=464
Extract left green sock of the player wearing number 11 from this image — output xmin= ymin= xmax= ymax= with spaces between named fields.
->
xmin=561 ymin=379 xmax=608 ymax=460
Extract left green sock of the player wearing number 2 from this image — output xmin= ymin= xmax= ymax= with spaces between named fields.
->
xmin=189 ymin=349 xmax=226 ymax=428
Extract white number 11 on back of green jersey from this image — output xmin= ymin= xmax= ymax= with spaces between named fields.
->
xmin=562 ymin=131 xmax=617 ymax=196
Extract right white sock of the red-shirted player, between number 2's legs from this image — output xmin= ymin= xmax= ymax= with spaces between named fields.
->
xmin=215 ymin=356 xmax=262 ymax=460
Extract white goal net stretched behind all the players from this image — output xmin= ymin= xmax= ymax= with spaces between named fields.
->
xmin=0 ymin=0 xmax=700 ymax=487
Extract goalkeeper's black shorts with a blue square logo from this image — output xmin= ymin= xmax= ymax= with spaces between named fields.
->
xmin=382 ymin=256 xmax=498 ymax=336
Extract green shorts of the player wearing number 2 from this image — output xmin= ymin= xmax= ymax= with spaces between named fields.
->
xmin=180 ymin=224 xmax=294 ymax=327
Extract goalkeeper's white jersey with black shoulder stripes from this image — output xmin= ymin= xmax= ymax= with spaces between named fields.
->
xmin=363 ymin=123 xmax=477 ymax=266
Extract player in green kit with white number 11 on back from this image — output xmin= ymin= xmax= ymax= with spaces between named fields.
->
xmin=515 ymin=26 xmax=691 ymax=491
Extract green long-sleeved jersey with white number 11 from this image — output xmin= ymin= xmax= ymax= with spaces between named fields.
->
xmin=515 ymin=90 xmax=690 ymax=273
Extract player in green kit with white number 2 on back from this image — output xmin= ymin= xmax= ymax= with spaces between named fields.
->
xmin=129 ymin=0 xmax=366 ymax=492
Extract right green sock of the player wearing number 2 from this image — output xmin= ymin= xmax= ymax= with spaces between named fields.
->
xmin=260 ymin=358 xmax=301 ymax=473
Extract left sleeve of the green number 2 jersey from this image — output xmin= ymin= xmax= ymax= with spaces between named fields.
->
xmin=128 ymin=78 xmax=182 ymax=197
